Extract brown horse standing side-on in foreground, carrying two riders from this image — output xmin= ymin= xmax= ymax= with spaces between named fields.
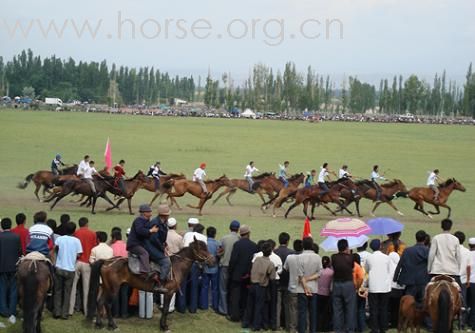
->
xmin=87 ymin=238 xmax=214 ymax=331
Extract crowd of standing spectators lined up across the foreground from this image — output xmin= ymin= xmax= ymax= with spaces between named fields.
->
xmin=0 ymin=212 xmax=475 ymax=333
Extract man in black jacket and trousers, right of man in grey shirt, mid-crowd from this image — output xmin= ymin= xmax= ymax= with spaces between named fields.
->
xmin=228 ymin=225 xmax=257 ymax=321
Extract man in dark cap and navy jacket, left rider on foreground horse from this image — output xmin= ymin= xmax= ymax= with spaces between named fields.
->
xmin=127 ymin=204 xmax=168 ymax=292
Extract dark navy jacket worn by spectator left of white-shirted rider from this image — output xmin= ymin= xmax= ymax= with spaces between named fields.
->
xmin=393 ymin=244 xmax=430 ymax=286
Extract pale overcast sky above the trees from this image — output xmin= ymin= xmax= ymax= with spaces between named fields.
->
xmin=0 ymin=0 xmax=475 ymax=83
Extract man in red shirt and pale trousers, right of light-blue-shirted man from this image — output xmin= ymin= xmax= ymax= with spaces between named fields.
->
xmin=69 ymin=217 xmax=97 ymax=316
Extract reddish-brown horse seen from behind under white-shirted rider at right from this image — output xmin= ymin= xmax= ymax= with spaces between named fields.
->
xmin=425 ymin=275 xmax=462 ymax=333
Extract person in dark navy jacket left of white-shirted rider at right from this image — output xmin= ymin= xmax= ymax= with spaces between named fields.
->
xmin=393 ymin=230 xmax=430 ymax=304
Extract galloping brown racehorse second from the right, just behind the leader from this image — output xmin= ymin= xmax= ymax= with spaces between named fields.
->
xmin=355 ymin=179 xmax=407 ymax=216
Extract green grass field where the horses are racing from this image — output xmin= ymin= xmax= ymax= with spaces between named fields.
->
xmin=0 ymin=111 xmax=475 ymax=332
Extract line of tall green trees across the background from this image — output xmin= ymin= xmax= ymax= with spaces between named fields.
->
xmin=0 ymin=50 xmax=475 ymax=117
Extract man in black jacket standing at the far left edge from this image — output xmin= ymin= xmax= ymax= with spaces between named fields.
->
xmin=0 ymin=218 xmax=22 ymax=323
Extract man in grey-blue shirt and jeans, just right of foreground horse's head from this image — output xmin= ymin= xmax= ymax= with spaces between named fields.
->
xmin=200 ymin=227 xmax=221 ymax=312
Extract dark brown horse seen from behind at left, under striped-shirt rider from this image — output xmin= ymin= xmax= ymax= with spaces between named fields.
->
xmin=17 ymin=252 xmax=53 ymax=333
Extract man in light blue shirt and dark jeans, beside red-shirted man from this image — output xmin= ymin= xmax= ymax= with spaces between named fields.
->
xmin=53 ymin=222 xmax=82 ymax=319
